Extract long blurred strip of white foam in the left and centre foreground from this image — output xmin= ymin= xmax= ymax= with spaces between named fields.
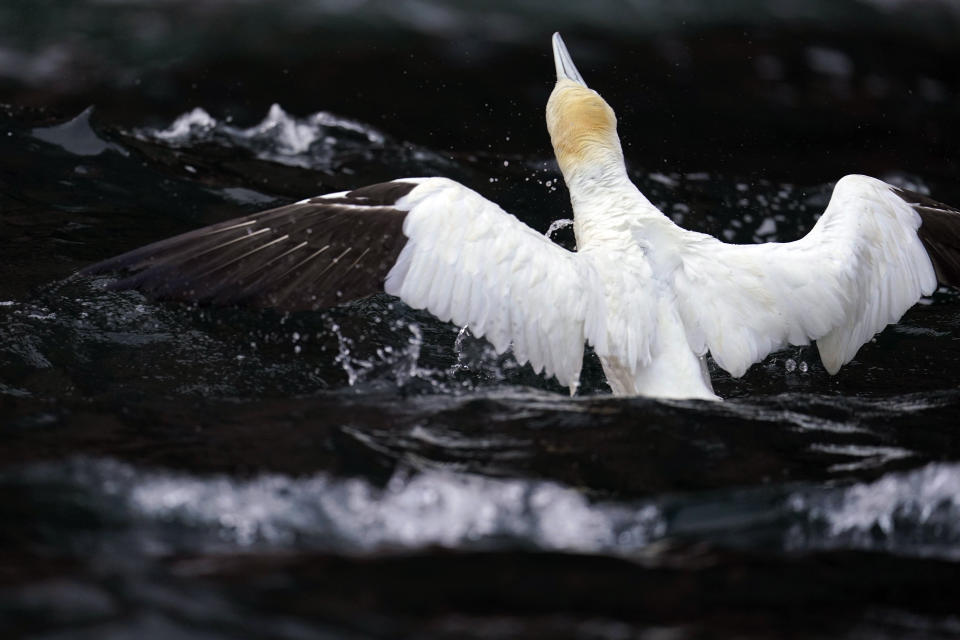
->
xmin=9 ymin=459 xmax=663 ymax=553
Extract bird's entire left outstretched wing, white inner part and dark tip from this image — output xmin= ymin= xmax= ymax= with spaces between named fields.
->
xmin=83 ymin=178 xmax=600 ymax=388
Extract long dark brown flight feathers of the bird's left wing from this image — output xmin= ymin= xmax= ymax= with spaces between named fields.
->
xmin=81 ymin=182 xmax=416 ymax=311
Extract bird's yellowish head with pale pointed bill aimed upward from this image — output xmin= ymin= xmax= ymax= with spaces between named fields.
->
xmin=547 ymin=33 xmax=623 ymax=184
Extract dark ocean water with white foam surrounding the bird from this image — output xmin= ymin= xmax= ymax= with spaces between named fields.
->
xmin=0 ymin=0 xmax=960 ymax=639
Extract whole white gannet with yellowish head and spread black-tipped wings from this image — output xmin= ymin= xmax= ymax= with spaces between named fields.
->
xmin=84 ymin=34 xmax=960 ymax=400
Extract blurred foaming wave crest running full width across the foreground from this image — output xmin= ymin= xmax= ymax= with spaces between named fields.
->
xmin=7 ymin=458 xmax=960 ymax=558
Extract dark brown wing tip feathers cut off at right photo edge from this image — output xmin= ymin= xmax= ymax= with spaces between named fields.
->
xmin=894 ymin=188 xmax=960 ymax=287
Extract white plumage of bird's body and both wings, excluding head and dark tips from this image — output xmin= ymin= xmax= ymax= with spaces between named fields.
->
xmin=385 ymin=176 xmax=937 ymax=399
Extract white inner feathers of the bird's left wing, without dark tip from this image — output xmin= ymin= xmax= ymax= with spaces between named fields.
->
xmin=384 ymin=178 xmax=599 ymax=390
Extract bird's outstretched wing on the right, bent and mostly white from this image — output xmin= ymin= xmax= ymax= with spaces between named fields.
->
xmin=676 ymin=175 xmax=948 ymax=376
